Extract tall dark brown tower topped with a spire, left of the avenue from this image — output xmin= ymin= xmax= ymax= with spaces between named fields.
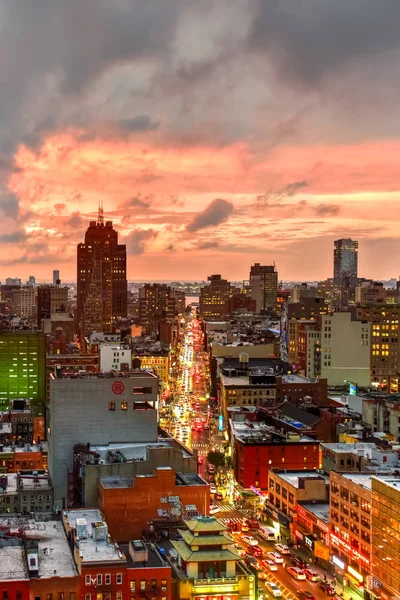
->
xmin=77 ymin=202 xmax=128 ymax=337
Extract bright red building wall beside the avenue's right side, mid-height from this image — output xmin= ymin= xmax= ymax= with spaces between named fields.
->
xmin=235 ymin=441 xmax=319 ymax=490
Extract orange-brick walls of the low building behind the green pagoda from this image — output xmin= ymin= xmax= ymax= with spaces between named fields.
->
xmin=99 ymin=469 xmax=210 ymax=542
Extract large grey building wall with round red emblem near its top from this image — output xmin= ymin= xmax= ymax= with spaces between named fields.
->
xmin=48 ymin=374 xmax=158 ymax=506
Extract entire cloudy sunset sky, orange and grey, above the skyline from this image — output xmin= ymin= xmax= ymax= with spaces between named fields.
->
xmin=0 ymin=0 xmax=400 ymax=281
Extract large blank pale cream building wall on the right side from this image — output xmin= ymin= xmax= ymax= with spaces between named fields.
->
xmin=321 ymin=312 xmax=373 ymax=387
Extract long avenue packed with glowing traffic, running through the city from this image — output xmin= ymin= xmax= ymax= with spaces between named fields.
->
xmin=160 ymin=311 xmax=344 ymax=600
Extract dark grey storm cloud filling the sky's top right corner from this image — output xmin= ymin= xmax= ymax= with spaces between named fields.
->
xmin=248 ymin=0 xmax=400 ymax=86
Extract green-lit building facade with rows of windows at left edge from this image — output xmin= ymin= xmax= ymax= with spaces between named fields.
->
xmin=0 ymin=331 xmax=46 ymax=414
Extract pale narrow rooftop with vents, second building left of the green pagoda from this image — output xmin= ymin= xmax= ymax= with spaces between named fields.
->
xmin=63 ymin=509 xmax=126 ymax=564
